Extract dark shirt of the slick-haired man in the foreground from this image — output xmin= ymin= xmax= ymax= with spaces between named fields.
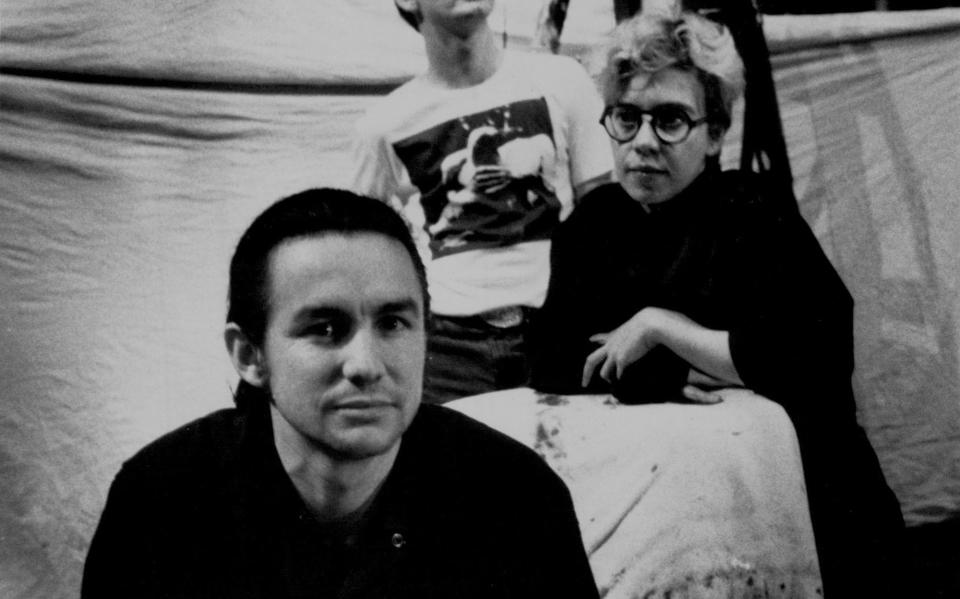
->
xmin=82 ymin=403 xmax=597 ymax=599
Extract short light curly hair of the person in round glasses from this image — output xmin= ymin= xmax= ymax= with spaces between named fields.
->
xmin=594 ymin=10 xmax=744 ymax=138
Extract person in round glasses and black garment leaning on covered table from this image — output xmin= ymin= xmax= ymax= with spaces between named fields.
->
xmin=530 ymin=7 xmax=903 ymax=597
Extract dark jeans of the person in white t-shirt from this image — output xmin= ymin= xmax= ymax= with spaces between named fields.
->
xmin=423 ymin=308 xmax=532 ymax=403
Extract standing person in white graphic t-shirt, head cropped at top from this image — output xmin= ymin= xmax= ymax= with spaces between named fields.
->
xmin=351 ymin=0 xmax=612 ymax=403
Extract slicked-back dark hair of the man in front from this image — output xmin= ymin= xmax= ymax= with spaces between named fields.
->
xmin=227 ymin=188 xmax=430 ymax=345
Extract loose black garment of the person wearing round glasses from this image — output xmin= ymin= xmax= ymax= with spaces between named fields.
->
xmin=530 ymin=169 xmax=903 ymax=597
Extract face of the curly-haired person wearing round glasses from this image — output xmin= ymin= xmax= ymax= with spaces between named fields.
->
xmin=611 ymin=68 xmax=722 ymax=209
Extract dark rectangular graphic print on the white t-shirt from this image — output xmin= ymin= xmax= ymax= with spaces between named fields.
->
xmin=394 ymin=98 xmax=560 ymax=258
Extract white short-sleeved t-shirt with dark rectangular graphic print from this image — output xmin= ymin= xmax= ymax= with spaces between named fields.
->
xmin=352 ymin=52 xmax=611 ymax=315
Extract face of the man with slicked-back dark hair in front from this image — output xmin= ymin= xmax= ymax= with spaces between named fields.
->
xmin=263 ymin=233 xmax=426 ymax=460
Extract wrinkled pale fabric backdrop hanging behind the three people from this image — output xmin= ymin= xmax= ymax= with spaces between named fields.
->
xmin=0 ymin=0 xmax=960 ymax=598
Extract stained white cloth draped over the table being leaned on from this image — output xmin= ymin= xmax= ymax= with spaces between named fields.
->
xmin=447 ymin=388 xmax=821 ymax=599
